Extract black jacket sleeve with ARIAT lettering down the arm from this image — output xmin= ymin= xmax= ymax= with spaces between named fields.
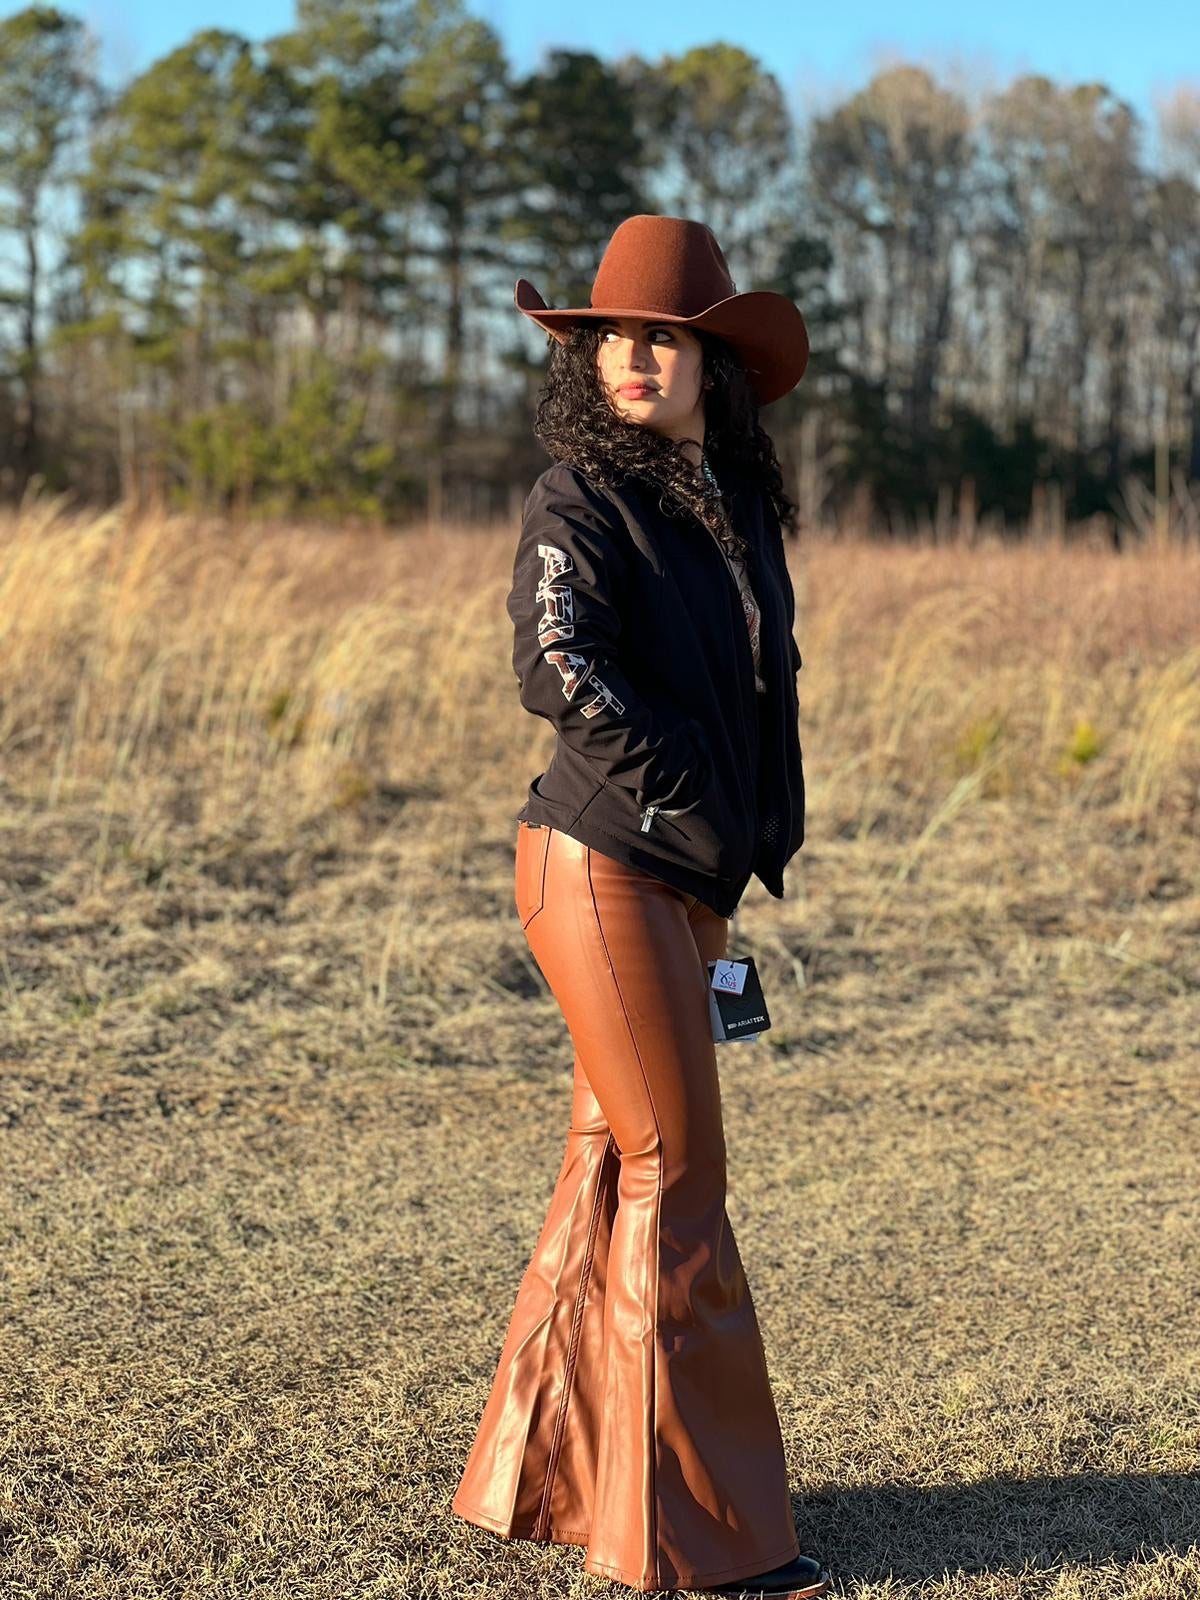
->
xmin=506 ymin=467 xmax=712 ymax=808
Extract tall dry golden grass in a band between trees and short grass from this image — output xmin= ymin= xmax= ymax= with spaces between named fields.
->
xmin=0 ymin=499 xmax=1200 ymax=840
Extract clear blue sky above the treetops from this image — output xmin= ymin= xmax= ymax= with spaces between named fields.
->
xmin=18 ymin=0 xmax=1200 ymax=139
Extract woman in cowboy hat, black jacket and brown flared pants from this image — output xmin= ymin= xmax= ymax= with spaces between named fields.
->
xmin=453 ymin=216 xmax=829 ymax=1597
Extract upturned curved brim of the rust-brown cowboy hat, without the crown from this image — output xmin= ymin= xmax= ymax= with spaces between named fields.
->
xmin=514 ymin=278 xmax=808 ymax=405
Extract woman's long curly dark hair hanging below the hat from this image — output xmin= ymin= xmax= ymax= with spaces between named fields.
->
xmin=533 ymin=318 xmax=795 ymax=555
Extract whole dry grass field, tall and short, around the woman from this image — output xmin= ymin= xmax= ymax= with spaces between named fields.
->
xmin=0 ymin=499 xmax=1200 ymax=1600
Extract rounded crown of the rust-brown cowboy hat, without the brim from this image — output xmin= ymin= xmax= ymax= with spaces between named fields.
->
xmin=590 ymin=214 xmax=738 ymax=317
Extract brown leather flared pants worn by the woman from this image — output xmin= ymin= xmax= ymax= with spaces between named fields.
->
xmin=453 ymin=822 xmax=798 ymax=1589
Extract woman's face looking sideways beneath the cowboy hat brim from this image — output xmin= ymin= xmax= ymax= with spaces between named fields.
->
xmin=595 ymin=317 xmax=704 ymax=443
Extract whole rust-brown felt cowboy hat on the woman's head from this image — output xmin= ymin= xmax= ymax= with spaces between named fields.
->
xmin=514 ymin=213 xmax=808 ymax=405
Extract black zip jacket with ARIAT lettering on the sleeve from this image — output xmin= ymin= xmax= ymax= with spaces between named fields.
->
xmin=506 ymin=461 xmax=805 ymax=917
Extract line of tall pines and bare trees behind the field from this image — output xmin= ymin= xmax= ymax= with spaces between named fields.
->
xmin=0 ymin=0 xmax=1200 ymax=528
